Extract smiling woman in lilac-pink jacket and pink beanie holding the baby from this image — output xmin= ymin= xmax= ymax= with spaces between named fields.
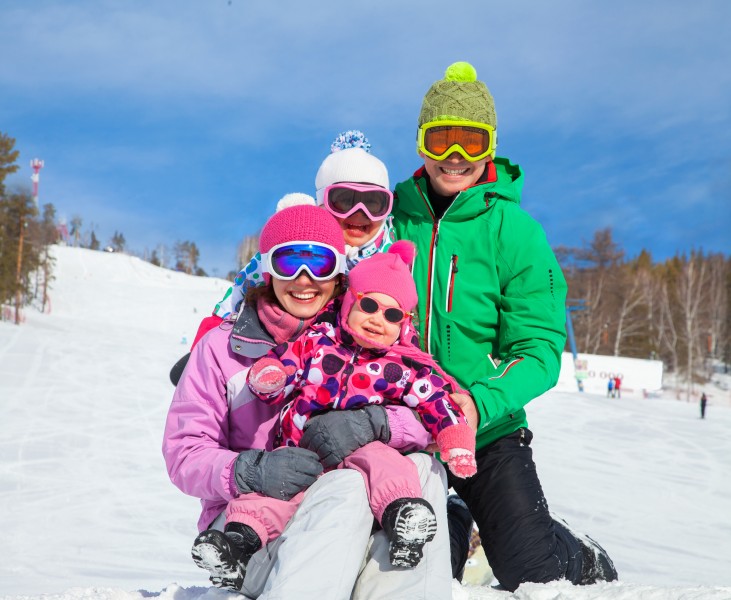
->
xmin=163 ymin=206 xmax=451 ymax=599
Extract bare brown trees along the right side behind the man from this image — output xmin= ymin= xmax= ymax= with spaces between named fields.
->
xmin=555 ymin=229 xmax=731 ymax=396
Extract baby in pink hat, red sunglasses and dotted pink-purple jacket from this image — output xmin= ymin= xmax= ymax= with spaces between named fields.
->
xmin=232 ymin=241 xmax=476 ymax=567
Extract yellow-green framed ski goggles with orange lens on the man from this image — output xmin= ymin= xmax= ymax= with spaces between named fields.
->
xmin=416 ymin=121 xmax=497 ymax=162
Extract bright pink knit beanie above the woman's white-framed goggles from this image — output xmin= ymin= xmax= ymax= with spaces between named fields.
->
xmin=259 ymin=204 xmax=345 ymax=254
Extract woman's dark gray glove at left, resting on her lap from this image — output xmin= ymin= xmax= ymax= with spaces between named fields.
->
xmin=234 ymin=447 xmax=322 ymax=500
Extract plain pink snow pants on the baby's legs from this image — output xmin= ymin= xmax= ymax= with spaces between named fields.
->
xmin=226 ymin=442 xmax=421 ymax=546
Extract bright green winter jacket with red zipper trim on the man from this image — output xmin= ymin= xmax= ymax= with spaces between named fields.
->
xmin=393 ymin=158 xmax=566 ymax=449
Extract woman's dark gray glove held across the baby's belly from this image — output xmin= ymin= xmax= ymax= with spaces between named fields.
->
xmin=300 ymin=404 xmax=391 ymax=468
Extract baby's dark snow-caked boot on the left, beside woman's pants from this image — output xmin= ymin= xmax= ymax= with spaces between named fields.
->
xmin=191 ymin=523 xmax=261 ymax=591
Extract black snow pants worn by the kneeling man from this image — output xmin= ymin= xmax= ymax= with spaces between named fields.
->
xmin=449 ymin=429 xmax=582 ymax=592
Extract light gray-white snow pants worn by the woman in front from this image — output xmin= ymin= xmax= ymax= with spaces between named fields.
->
xmin=242 ymin=454 xmax=452 ymax=600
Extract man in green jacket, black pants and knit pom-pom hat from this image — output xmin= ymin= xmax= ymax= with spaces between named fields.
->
xmin=393 ymin=62 xmax=617 ymax=591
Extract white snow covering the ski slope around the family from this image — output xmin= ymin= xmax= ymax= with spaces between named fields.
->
xmin=0 ymin=247 xmax=731 ymax=600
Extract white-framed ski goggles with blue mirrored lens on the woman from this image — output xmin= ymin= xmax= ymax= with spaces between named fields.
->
xmin=261 ymin=242 xmax=345 ymax=281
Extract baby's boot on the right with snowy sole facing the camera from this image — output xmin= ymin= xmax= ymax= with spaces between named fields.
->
xmin=381 ymin=498 xmax=437 ymax=567
